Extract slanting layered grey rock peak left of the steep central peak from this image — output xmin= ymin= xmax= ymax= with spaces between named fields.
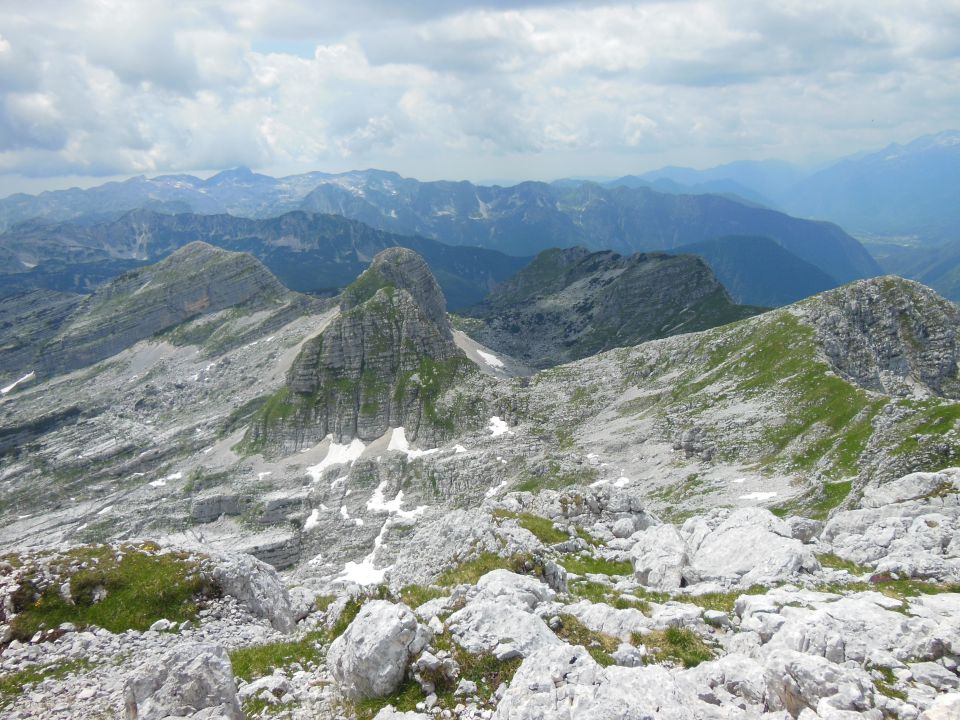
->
xmin=0 ymin=242 xmax=288 ymax=386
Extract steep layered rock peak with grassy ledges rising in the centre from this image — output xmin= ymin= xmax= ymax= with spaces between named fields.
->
xmin=248 ymin=248 xmax=474 ymax=451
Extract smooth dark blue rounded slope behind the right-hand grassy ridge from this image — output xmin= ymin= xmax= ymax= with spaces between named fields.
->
xmin=675 ymin=236 xmax=837 ymax=307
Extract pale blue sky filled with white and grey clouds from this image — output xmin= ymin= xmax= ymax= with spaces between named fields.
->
xmin=0 ymin=0 xmax=960 ymax=195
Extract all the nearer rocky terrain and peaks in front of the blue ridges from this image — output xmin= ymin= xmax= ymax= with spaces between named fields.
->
xmin=0 ymin=242 xmax=960 ymax=720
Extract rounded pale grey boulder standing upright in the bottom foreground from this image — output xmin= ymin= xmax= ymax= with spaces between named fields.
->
xmin=327 ymin=600 xmax=430 ymax=700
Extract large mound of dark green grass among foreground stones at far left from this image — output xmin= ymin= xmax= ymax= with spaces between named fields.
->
xmin=11 ymin=545 xmax=217 ymax=640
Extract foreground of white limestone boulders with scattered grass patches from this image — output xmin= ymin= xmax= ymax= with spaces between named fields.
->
xmin=0 ymin=469 xmax=960 ymax=720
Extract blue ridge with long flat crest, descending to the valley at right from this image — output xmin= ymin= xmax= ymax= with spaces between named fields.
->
xmin=303 ymin=173 xmax=880 ymax=282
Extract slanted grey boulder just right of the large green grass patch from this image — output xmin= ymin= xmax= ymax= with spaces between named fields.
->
xmin=213 ymin=554 xmax=295 ymax=632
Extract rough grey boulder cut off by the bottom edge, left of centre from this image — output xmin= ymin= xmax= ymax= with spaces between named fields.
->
xmin=124 ymin=643 xmax=243 ymax=720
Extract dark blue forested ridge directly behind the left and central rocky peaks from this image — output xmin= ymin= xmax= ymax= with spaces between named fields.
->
xmin=0 ymin=210 xmax=527 ymax=307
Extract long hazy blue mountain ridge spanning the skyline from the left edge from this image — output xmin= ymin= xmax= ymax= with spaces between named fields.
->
xmin=0 ymin=168 xmax=880 ymax=286
